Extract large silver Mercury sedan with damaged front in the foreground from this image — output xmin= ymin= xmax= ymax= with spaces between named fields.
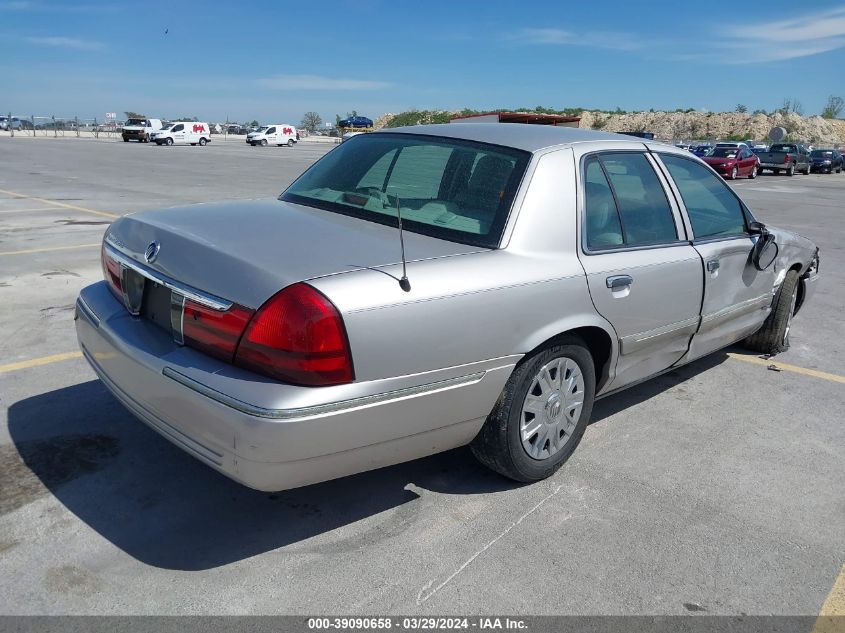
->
xmin=76 ymin=123 xmax=819 ymax=490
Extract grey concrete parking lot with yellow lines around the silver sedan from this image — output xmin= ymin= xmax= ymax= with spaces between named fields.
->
xmin=0 ymin=138 xmax=845 ymax=615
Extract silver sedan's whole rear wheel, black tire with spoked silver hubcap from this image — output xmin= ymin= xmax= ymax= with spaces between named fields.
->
xmin=470 ymin=337 xmax=596 ymax=482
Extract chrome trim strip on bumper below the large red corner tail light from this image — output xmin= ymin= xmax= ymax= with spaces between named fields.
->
xmin=161 ymin=367 xmax=487 ymax=420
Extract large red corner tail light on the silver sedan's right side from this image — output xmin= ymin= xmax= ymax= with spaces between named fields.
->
xmin=235 ymin=283 xmax=355 ymax=387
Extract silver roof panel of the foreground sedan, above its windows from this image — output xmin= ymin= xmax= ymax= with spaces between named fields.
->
xmin=375 ymin=123 xmax=652 ymax=152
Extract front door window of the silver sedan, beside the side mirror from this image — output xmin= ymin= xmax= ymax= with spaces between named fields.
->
xmin=660 ymin=154 xmax=746 ymax=239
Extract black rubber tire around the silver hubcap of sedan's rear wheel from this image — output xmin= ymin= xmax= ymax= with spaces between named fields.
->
xmin=470 ymin=337 xmax=596 ymax=482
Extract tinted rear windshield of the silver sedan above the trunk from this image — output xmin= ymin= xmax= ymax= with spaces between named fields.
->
xmin=281 ymin=133 xmax=531 ymax=248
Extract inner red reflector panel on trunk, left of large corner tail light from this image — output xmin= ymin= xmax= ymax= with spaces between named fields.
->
xmin=182 ymin=299 xmax=253 ymax=363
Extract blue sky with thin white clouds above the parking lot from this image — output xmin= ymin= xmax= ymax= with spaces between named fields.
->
xmin=0 ymin=0 xmax=845 ymax=123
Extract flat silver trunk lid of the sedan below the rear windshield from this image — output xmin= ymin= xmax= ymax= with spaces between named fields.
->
xmin=107 ymin=200 xmax=480 ymax=308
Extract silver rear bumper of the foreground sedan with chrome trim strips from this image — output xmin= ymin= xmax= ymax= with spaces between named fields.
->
xmin=75 ymin=282 xmax=518 ymax=490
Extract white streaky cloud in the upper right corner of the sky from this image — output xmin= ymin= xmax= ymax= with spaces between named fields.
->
xmin=694 ymin=7 xmax=845 ymax=64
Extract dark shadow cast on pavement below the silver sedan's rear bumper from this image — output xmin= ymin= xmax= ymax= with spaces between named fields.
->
xmin=6 ymin=380 xmax=520 ymax=571
